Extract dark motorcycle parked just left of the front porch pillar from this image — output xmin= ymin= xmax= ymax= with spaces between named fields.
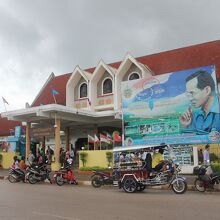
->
xmin=26 ymin=163 xmax=52 ymax=184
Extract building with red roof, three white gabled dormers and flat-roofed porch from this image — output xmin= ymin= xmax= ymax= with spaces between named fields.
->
xmin=1 ymin=40 xmax=220 ymax=172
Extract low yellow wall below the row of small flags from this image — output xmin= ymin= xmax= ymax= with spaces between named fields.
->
xmin=79 ymin=150 xmax=112 ymax=168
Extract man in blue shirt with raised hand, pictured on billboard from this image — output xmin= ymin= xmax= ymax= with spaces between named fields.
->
xmin=179 ymin=70 xmax=220 ymax=134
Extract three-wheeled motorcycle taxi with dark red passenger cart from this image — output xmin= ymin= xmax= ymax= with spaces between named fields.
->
xmin=113 ymin=146 xmax=187 ymax=194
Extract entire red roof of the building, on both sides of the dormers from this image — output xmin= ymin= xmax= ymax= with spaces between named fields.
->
xmin=32 ymin=40 xmax=220 ymax=106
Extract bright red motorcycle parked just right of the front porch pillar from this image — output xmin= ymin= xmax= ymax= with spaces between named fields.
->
xmin=53 ymin=165 xmax=78 ymax=186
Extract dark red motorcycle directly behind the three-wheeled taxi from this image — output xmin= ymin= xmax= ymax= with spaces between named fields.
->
xmin=91 ymin=170 xmax=117 ymax=188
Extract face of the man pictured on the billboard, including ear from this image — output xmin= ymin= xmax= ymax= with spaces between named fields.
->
xmin=186 ymin=78 xmax=211 ymax=108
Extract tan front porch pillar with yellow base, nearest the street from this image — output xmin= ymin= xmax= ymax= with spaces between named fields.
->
xmin=51 ymin=118 xmax=60 ymax=170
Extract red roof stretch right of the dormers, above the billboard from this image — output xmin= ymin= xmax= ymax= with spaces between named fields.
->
xmin=136 ymin=40 xmax=220 ymax=78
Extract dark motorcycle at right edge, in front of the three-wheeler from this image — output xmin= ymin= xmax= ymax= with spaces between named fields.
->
xmin=193 ymin=165 xmax=220 ymax=192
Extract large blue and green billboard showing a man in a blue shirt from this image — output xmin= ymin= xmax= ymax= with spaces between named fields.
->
xmin=122 ymin=66 xmax=220 ymax=146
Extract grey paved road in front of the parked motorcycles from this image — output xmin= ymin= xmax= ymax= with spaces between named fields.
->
xmin=0 ymin=180 xmax=220 ymax=220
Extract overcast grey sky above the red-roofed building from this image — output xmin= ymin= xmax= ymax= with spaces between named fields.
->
xmin=0 ymin=0 xmax=220 ymax=112
